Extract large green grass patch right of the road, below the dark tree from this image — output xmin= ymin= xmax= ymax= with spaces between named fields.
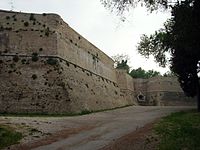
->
xmin=154 ymin=111 xmax=200 ymax=150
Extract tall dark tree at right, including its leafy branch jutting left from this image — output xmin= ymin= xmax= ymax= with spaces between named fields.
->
xmin=138 ymin=0 xmax=200 ymax=111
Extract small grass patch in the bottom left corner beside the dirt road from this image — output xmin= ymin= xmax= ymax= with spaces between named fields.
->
xmin=0 ymin=125 xmax=22 ymax=149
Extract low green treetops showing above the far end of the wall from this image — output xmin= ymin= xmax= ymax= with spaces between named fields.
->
xmin=129 ymin=67 xmax=160 ymax=79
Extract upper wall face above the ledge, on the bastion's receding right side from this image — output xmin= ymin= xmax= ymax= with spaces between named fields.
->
xmin=55 ymin=21 xmax=117 ymax=82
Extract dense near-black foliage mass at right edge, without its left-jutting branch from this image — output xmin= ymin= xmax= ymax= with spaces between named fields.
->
xmin=171 ymin=0 xmax=200 ymax=96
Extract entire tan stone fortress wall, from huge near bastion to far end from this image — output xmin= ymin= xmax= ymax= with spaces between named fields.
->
xmin=0 ymin=11 xmax=195 ymax=113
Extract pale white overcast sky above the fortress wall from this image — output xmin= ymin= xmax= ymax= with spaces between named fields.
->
xmin=0 ymin=0 xmax=170 ymax=73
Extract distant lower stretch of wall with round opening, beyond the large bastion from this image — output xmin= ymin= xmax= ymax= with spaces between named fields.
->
xmin=117 ymin=69 xmax=196 ymax=106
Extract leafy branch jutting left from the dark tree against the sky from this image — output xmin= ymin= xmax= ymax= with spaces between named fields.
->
xmin=137 ymin=20 xmax=172 ymax=67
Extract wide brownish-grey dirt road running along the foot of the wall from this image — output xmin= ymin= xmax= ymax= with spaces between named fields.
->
xmin=0 ymin=106 xmax=194 ymax=150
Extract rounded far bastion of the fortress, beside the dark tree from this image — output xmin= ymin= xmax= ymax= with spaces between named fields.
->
xmin=147 ymin=77 xmax=196 ymax=105
